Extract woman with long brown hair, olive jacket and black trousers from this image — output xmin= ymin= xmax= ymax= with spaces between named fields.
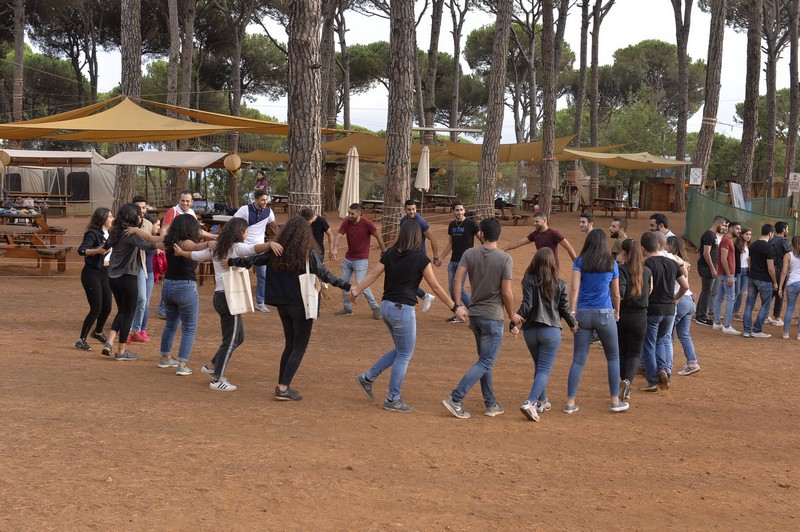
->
xmin=617 ymin=238 xmax=653 ymax=401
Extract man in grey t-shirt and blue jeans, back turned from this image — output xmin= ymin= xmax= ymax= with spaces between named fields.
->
xmin=442 ymin=218 xmax=514 ymax=419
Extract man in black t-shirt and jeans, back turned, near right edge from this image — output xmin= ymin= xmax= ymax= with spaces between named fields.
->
xmin=744 ymin=224 xmax=778 ymax=338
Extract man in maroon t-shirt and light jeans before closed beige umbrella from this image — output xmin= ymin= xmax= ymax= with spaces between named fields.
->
xmin=330 ymin=203 xmax=386 ymax=320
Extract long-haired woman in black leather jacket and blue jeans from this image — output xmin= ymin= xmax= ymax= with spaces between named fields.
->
xmin=511 ymin=248 xmax=578 ymax=421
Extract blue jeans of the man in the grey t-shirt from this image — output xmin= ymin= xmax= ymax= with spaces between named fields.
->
xmin=450 ymin=316 xmax=503 ymax=407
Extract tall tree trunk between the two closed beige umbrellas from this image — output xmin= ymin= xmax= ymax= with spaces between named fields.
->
xmin=381 ymin=0 xmax=416 ymax=241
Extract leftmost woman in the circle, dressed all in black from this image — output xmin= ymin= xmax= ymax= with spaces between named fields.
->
xmin=75 ymin=207 xmax=114 ymax=351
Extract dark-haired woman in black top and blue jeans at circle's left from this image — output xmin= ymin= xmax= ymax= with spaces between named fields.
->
xmin=158 ymin=214 xmax=209 ymax=376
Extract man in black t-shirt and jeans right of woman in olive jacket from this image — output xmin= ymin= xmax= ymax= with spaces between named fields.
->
xmin=639 ymin=232 xmax=689 ymax=393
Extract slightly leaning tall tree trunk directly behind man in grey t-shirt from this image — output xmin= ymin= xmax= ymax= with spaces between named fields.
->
xmin=475 ymin=0 xmax=512 ymax=218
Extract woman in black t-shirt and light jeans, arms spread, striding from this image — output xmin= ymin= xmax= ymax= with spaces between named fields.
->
xmin=350 ymin=223 xmax=466 ymax=412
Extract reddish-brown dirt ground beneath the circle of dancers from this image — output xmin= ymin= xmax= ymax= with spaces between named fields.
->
xmin=0 ymin=206 xmax=800 ymax=530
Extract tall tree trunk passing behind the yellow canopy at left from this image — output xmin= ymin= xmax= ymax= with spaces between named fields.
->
xmin=113 ymin=0 xmax=142 ymax=212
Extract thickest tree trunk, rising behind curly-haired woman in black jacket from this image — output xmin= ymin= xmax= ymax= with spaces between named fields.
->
xmin=287 ymin=0 xmax=322 ymax=215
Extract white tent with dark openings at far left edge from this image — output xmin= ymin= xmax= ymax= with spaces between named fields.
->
xmin=2 ymin=150 xmax=116 ymax=215
